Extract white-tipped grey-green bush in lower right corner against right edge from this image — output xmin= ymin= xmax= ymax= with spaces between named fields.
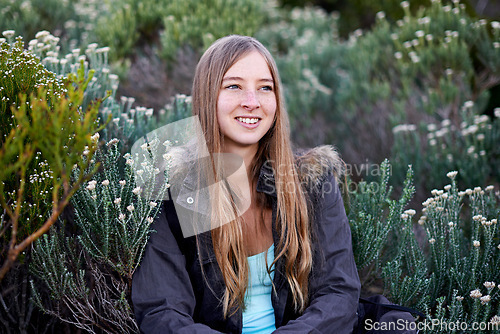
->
xmin=382 ymin=172 xmax=500 ymax=333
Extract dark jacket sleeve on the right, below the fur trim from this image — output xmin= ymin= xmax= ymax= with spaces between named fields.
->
xmin=273 ymin=176 xmax=361 ymax=334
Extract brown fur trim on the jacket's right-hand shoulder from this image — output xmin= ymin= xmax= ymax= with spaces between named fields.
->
xmin=295 ymin=145 xmax=345 ymax=193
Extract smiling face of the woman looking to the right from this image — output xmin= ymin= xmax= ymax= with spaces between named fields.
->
xmin=217 ymin=51 xmax=276 ymax=152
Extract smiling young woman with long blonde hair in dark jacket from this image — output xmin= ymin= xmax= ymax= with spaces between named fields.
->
xmin=132 ymin=35 xmax=360 ymax=334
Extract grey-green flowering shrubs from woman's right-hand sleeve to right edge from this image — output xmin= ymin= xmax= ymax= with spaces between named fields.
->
xmin=349 ymin=162 xmax=500 ymax=333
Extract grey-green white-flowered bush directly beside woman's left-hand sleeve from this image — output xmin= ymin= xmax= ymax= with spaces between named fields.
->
xmin=30 ymin=139 xmax=168 ymax=333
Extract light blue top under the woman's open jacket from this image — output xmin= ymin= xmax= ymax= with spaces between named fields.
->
xmin=243 ymin=244 xmax=276 ymax=334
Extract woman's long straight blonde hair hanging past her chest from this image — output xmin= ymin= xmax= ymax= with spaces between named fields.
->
xmin=192 ymin=35 xmax=312 ymax=317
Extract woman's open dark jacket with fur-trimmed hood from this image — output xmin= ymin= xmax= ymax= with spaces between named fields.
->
xmin=132 ymin=146 xmax=360 ymax=334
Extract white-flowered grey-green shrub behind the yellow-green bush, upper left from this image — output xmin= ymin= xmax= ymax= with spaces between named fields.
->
xmin=28 ymin=31 xmax=177 ymax=153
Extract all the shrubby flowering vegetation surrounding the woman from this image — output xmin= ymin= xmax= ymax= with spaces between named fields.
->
xmin=0 ymin=0 xmax=500 ymax=333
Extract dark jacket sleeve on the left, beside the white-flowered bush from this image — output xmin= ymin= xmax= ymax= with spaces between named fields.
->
xmin=132 ymin=201 xmax=220 ymax=334
